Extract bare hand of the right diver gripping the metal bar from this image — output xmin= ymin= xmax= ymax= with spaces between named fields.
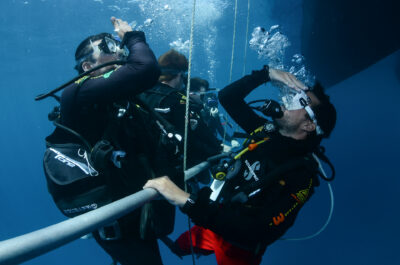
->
xmin=143 ymin=176 xmax=190 ymax=207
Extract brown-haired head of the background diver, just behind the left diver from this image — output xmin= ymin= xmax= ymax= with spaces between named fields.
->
xmin=158 ymin=49 xmax=189 ymax=89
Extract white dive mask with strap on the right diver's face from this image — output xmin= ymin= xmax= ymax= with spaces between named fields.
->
xmin=282 ymin=90 xmax=324 ymax=135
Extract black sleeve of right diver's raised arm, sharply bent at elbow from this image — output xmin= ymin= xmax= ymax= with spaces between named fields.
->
xmin=218 ymin=69 xmax=269 ymax=133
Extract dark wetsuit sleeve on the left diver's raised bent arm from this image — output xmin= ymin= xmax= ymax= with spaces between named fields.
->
xmin=76 ymin=31 xmax=160 ymax=105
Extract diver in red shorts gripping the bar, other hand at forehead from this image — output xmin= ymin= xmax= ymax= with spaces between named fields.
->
xmin=144 ymin=66 xmax=336 ymax=265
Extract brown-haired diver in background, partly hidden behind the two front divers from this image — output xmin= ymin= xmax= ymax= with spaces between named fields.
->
xmin=140 ymin=49 xmax=222 ymax=185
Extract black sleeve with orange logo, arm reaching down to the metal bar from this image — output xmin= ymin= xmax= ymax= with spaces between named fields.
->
xmin=182 ymin=169 xmax=313 ymax=246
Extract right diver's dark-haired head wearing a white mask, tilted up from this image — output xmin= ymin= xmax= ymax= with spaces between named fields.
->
xmin=275 ymin=83 xmax=336 ymax=140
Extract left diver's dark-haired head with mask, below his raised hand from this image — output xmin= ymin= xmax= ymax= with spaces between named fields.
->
xmin=75 ymin=33 xmax=127 ymax=75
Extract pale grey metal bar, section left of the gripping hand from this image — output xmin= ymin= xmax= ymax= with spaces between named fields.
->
xmin=0 ymin=189 xmax=158 ymax=265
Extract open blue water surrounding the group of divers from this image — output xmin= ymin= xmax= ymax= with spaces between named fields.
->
xmin=0 ymin=0 xmax=400 ymax=265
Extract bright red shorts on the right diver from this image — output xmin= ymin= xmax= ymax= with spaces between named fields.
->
xmin=176 ymin=225 xmax=262 ymax=265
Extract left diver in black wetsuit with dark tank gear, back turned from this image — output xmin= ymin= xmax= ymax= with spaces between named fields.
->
xmin=37 ymin=17 xmax=175 ymax=265
